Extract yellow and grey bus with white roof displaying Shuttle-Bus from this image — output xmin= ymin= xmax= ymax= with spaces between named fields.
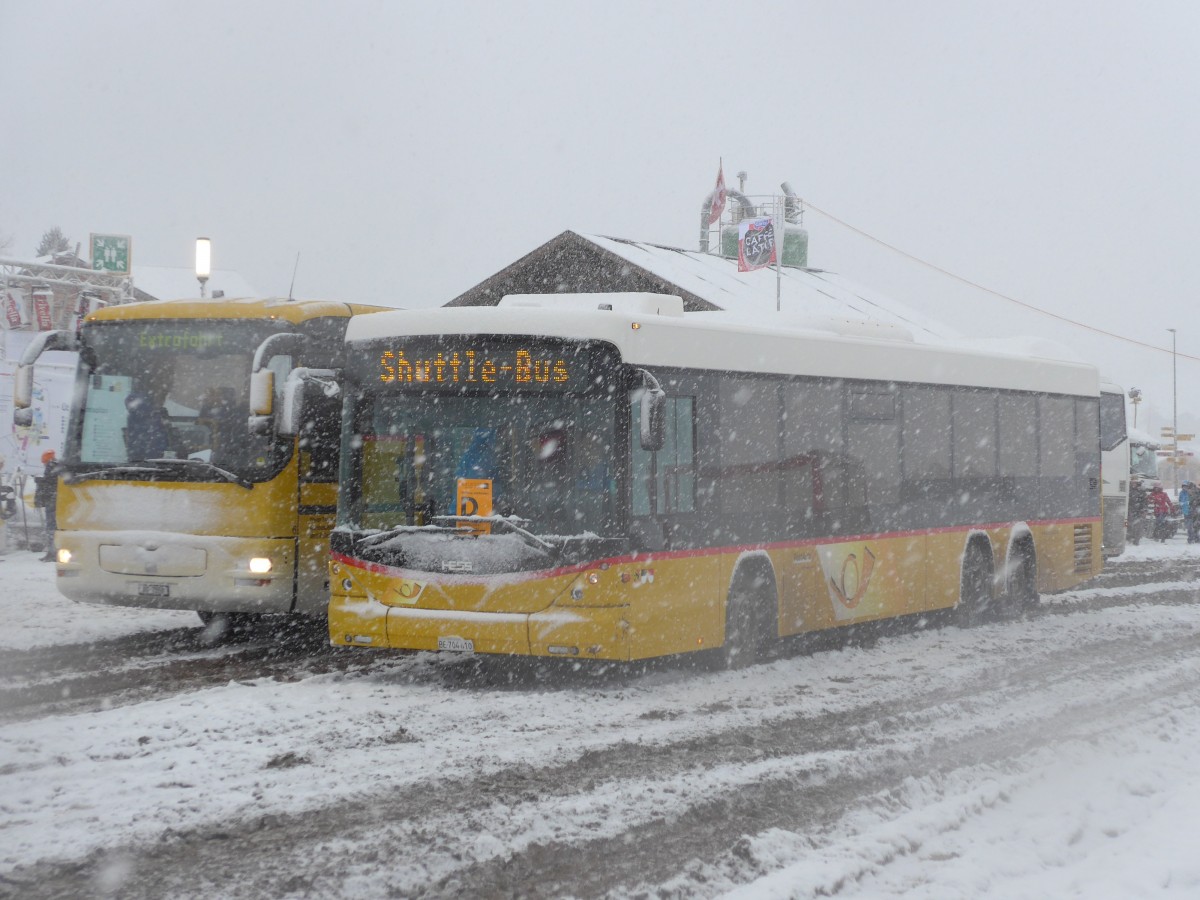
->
xmin=329 ymin=294 xmax=1102 ymax=665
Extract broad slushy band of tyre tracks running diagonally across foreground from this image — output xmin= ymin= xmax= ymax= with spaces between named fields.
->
xmin=11 ymin=589 xmax=1200 ymax=898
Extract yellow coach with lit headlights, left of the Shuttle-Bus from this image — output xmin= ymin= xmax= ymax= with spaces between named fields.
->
xmin=16 ymin=300 xmax=379 ymax=624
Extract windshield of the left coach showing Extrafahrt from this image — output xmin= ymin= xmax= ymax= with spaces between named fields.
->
xmin=66 ymin=319 xmax=290 ymax=481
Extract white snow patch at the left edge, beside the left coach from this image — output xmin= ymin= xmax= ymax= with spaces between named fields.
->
xmin=0 ymin=550 xmax=199 ymax=650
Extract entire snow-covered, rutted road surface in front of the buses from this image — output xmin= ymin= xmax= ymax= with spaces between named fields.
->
xmin=0 ymin=542 xmax=1200 ymax=898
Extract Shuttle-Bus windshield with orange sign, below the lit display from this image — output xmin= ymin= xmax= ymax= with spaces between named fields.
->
xmin=340 ymin=391 xmax=619 ymax=538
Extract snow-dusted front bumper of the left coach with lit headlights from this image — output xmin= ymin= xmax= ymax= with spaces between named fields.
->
xmin=56 ymin=532 xmax=295 ymax=613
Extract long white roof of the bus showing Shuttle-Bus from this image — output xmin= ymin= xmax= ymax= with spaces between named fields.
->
xmin=346 ymin=294 xmax=1099 ymax=397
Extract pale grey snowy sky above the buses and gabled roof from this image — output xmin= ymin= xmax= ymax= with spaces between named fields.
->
xmin=7 ymin=0 xmax=1200 ymax=430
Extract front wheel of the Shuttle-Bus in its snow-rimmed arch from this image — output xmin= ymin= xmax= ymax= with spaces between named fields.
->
xmin=721 ymin=551 xmax=779 ymax=668
